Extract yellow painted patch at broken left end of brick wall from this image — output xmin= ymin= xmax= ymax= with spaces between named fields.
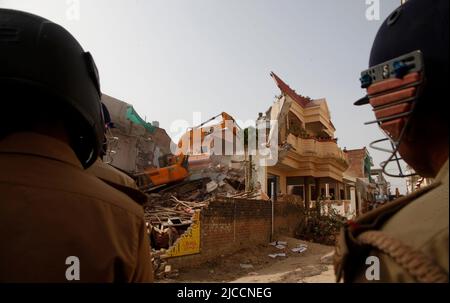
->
xmin=164 ymin=211 xmax=200 ymax=258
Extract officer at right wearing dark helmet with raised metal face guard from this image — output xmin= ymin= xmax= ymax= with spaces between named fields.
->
xmin=335 ymin=0 xmax=449 ymax=282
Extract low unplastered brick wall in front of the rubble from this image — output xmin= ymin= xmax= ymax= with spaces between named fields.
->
xmin=169 ymin=199 xmax=301 ymax=268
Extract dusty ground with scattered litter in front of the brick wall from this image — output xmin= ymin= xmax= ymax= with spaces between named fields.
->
xmin=162 ymin=237 xmax=335 ymax=283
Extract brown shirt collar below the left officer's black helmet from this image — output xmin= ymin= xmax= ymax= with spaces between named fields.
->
xmin=0 ymin=132 xmax=82 ymax=168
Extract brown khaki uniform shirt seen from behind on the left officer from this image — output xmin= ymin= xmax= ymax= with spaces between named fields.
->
xmin=0 ymin=133 xmax=153 ymax=282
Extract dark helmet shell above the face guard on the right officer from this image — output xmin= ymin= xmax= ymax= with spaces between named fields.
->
xmin=355 ymin=0 xmax=450 ymax=110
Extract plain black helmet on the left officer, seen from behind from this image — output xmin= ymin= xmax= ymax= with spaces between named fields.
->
xmin=0 ymin=9 xmax=104 ymax=167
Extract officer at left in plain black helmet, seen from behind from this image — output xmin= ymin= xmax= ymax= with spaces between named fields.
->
xmin=0 ymin=9 xmax=153 ymax=282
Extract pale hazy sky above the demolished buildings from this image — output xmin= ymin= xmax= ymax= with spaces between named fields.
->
xmin=0 ymin=0 xmax=405 ymax=191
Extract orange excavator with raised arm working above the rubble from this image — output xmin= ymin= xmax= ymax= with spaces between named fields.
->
xmin=135 ymin=113 xmax=237 ymax=191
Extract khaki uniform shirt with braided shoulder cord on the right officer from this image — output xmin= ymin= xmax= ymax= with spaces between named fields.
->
xmin=335 ymin=162 xmax=449 ymax=283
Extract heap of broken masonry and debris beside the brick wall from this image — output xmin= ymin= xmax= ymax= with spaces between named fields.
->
xmin=144 ymin=156 xmax=269 ymax=279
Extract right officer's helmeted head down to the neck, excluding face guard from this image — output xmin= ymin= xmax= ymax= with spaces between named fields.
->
xmin=370 ymin=0 xmax=449 ymax=176
